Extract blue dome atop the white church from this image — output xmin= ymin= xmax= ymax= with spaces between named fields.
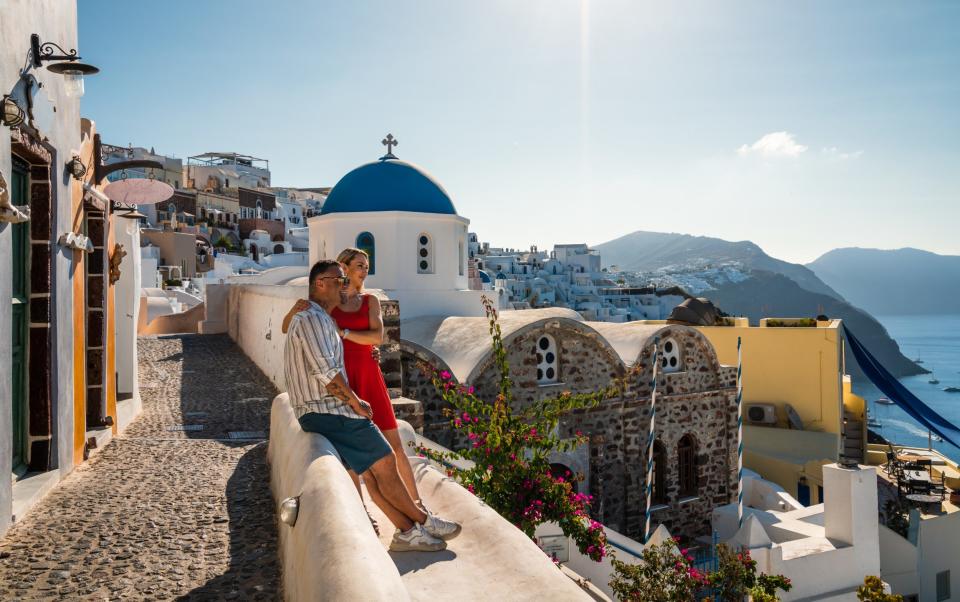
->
xmin=320 ymin=157 xmax=457 ymax=215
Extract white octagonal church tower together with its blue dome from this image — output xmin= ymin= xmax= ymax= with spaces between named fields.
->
xmin=308 ymin=139 xmax=497 ymax=318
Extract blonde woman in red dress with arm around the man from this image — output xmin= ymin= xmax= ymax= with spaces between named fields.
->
xmin=283 ymin=248 xmax=423 ymax=508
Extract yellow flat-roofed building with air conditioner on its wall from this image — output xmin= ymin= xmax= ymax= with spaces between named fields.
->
xmin=697 ymin=318 xmax=866 ymax=504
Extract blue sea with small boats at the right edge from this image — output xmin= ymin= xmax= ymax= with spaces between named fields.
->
xmin=847 ymin=314 xmax=960 ymax=462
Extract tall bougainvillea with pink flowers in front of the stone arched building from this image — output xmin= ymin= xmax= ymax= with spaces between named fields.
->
xmin=418 ymin=297 xmax=618 ymax=562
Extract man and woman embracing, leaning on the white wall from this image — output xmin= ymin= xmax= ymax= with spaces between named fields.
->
xmin=283 ymin=249 xmax=460 ymax=552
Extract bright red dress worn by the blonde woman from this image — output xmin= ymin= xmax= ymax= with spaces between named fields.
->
xmin=330 ymin=295 xmax=397 ymax=431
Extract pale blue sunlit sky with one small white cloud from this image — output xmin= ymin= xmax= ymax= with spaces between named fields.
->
xmin=78 ymin=0 xmax=960 ymax=263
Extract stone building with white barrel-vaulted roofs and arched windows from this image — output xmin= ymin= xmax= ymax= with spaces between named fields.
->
xmin=400 ymin=308 xmax=737 ymax=538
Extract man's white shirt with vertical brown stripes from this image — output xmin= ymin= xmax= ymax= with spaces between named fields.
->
xmin=283 ymin=301 xmax=363 ymax=418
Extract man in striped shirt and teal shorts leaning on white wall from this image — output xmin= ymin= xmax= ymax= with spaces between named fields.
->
xmin=284 ymin=259 xmax=460 ymax=552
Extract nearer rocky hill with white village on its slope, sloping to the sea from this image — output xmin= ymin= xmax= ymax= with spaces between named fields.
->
xmin=594 ymin=232 xmax=925 ymax=376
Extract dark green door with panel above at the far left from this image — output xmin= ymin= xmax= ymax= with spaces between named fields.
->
xmin=10 ymin=157 xmax=30 ymax=473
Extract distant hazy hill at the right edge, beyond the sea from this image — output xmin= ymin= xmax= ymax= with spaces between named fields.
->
xmin=807 ymin=248 xmax=960 ymax=315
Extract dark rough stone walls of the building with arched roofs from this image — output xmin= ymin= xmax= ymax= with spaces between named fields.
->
xmin=401 ymin=321 xmax=737 ymax=538
